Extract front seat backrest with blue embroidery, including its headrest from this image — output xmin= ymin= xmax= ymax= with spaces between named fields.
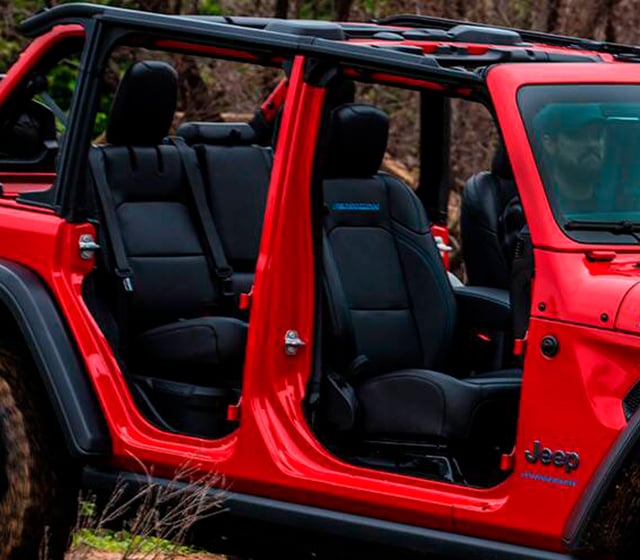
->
xmin=323 ymin=104 xmax=456 ymax=374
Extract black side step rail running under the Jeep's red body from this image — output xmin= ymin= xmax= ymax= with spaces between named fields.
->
xmin=84 ymin=467 xmax=575 ymax=560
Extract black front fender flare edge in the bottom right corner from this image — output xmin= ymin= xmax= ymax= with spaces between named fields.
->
xmin=562 ymin=400 xmax=640 ymax=550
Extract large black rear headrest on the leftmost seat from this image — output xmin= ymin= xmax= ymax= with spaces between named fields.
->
xmin=107 ymin=60 xmax=178 ymax=146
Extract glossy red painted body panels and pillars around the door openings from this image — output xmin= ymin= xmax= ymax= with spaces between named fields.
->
xmin=0 ymin=20 xmax=640 ymax=550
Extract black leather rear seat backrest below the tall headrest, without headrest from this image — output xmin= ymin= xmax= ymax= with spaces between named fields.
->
xmin=102 ymin=146 xmax=220 ymax=330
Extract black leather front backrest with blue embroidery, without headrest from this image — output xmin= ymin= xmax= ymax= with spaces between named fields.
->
xmin=324 ymin=174 xmax=456 ymax=372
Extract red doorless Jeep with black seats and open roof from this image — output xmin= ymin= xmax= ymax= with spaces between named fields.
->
xmin=0 ymin=4 xmax=640 ymax=560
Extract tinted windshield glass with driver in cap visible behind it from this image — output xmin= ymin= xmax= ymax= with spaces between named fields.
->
xmin=518 ymin=85 xmax=640 ymax=242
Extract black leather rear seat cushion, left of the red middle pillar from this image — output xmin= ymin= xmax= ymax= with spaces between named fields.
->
xmin=130 ymin=317 xmax=247 ymax=386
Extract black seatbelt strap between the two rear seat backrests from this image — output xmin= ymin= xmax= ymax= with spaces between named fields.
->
xmin=170 ymin=137 xmax=235 ymax=298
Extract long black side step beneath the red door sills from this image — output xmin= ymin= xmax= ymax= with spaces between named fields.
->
xmin=83 ymin=467 xmax=574 ymax=560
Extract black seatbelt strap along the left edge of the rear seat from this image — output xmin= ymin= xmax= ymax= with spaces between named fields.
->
xmin=89 ymin=147 xmax=134 ymax=293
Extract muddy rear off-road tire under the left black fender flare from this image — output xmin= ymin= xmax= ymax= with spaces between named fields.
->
xmin=0 ymin=346 xmax=77 ymax=560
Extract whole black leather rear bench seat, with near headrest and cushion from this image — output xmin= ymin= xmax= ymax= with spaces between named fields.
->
xmin=90 ymin=62 xmax=271 ymax=437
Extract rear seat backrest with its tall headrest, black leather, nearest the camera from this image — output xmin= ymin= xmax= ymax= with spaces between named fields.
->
xmin=93 ymin=61 xmax=220 ymax=331
